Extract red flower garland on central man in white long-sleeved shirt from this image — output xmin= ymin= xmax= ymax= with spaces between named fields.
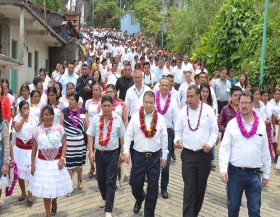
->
xmin=139 ymin=106 xmax=158 ymax=138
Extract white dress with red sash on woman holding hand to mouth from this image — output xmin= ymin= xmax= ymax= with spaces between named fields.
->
xmin=13 ymin=113 xmax=39 ymax=180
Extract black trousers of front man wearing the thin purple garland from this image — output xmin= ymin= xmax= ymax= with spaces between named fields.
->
xmin=181 ymin=148 xmax=211 ymax=217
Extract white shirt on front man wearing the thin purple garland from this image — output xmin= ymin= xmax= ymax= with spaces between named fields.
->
xmin=174 ymin=103 xmax=219 ymax=151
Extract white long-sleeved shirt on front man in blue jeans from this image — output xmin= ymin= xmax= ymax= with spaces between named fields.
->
xmin=219 ymin=118 xmax=271 ymax=179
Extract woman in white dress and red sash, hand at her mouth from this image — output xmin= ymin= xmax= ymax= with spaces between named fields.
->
xmin=13 ymin=100 xmax=39 ymax=206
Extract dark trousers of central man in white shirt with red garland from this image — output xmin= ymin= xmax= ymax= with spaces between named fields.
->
xmin=129 ymin=151 xmax=160 ymax=217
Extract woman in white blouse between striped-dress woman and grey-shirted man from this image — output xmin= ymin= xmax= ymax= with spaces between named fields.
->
xmin=85 ymin=84 xmax=101 ymax=178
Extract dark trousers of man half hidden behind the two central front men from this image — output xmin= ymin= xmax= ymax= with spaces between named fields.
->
xmin=161 ymin=130 xmax=174 ymax=190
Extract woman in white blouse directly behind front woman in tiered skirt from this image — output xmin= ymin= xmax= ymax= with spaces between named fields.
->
xmin=47 ymin=86 xmax=65 ymax=124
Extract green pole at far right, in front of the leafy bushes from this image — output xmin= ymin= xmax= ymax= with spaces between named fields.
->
xmin=259 ymin=0 xmax=269 ymax=88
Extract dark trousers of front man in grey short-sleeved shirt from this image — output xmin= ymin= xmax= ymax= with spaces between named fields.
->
xmin=95 ymin=149 xmax=119 ymax=212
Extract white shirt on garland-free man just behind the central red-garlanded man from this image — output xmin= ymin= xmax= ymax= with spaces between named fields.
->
xmin=125 ymin=84 xmax=151 ymax=117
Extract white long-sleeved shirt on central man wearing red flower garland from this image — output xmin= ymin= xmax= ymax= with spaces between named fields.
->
xmin=124 ymin=110 xmax=168 ymax=160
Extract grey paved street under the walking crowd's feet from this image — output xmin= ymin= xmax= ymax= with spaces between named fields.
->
xmin=1 ymin=148 xmax=280 ymax=217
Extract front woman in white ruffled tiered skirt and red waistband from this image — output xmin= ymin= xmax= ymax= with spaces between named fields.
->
xmin=28 ymin=105 xmax=73 ymax=217
